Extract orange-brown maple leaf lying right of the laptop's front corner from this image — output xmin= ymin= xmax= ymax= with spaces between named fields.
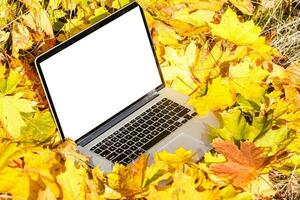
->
xmin=210 ymin=139 xmax=269 ymax=188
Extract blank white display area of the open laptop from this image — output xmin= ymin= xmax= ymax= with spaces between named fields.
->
xmin=40 ymin=7 xmax=162 ymax=140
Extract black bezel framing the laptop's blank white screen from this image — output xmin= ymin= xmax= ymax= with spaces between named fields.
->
xmin=35 ymin=1 xmax=165 ymax=143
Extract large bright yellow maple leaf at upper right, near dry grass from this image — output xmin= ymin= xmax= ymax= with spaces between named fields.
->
xmin=209 ymin=8 xmax=274 ymax=57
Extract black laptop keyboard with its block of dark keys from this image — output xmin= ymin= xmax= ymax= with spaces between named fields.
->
xmin=90 ymin=98 xmax=197 ymax=165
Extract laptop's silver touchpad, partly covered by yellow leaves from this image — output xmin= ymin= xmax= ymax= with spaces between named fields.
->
xmin=158 ymin=133 xmax=210 ymax=161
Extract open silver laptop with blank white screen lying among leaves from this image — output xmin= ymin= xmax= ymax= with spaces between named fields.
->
xmin=35 ymin=2 xmax=218 ymax=171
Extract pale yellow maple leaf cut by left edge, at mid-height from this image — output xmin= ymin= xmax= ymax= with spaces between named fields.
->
xmin=0 ymin=93 xmax=36 ymax=138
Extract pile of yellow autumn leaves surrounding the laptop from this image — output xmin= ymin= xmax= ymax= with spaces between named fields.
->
xmin=0 ymin=0 xmax=300 ymax=199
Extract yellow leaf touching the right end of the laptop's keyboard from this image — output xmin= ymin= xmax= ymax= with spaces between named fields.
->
xmin=188 ymin=77 xmax=236 ymax=115
